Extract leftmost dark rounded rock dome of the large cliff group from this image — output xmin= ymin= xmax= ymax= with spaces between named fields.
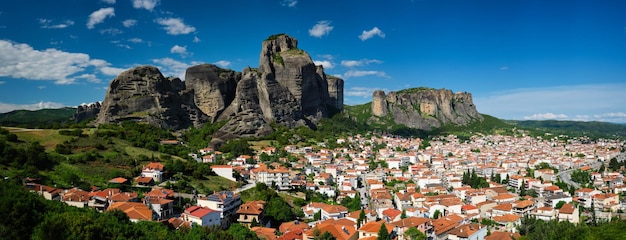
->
xmin=96 ymin=66 xmax=209 ymax=129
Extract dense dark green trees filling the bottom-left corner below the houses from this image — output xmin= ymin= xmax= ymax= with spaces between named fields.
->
xmin=0 ymin=180 xmax=258 ymax=240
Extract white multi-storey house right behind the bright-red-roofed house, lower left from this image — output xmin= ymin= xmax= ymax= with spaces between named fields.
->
xmin=196 ymin=191 xmax=241 ymax=227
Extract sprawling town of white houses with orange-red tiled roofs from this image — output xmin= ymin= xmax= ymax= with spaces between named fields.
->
xmin=25 ymin=131 xmax=626 ymax=240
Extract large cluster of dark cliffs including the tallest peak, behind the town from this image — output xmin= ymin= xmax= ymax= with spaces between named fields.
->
xmin=96 ymin=34 xmax=343 ymax=140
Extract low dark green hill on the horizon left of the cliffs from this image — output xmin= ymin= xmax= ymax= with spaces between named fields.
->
xmin=0 ymin=107 xmax=76 ymax=127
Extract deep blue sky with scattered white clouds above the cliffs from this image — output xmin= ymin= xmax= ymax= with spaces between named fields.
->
xmin=0 ymin=0 xmax=626 ymax=123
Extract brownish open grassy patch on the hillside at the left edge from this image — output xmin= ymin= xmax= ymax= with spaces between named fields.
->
xmin=3 ymin=127 xmax=72 ymax=152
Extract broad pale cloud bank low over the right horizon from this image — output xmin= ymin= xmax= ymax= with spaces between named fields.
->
xmin=474 ymin=83 xmax=626 ymax=122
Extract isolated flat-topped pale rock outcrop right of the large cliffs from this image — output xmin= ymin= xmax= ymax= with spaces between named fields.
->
xmin=372 ymin=88 xmax=483 ymax=130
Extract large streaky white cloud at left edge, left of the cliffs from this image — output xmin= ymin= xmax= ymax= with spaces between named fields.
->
xmin=0 ymin=40 xmax=122 ymax=84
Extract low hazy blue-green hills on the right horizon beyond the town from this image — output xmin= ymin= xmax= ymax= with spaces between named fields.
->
xmin=504 ymin=120 xmax=626 ymax=138
